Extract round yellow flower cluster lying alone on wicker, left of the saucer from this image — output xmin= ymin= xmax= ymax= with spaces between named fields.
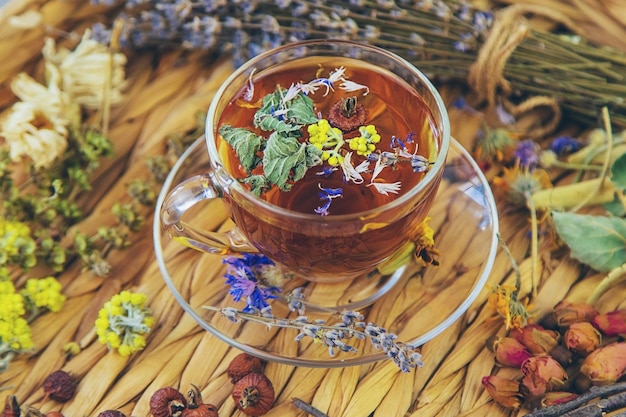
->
xmin=95 ymin=291 xmax=154 ymax=356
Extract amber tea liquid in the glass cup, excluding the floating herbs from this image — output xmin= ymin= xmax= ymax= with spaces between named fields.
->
xmin=217 ymin=57 xmax=440 ymax=281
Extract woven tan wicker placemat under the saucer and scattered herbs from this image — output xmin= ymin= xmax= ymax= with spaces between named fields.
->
xmin=0 ymin=0 xmax=626 ymax=417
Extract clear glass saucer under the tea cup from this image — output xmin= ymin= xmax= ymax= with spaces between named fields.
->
xmin=153 ymin=137 xmax=498 ymax=367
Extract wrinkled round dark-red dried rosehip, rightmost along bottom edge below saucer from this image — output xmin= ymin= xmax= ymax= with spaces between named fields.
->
xmin=232 ymin=373 xmax=274 ymax=416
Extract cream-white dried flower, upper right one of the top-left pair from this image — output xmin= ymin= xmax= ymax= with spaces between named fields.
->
xmin=42 ymin=30 xmax=126 ymax=108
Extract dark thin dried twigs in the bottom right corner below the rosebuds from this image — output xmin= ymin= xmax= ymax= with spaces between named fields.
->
xmin=525 ymin=382 xmax=626 ymax=417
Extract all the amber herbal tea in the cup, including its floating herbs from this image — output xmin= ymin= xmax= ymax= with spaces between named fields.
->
xmin=216 ymin=56 xmax=441 ymax=282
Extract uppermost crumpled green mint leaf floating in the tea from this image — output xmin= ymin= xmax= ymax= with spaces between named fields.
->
xmin=254 ymin=87 xmax=318 ymax=134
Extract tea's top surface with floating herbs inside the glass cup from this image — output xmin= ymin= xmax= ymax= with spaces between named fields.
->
xmin=219 ymin=58 xmax=437 ymax=215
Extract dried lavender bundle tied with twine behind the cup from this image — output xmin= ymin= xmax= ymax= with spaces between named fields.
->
xmin=92 ymin=0 xmax=626 ymax=126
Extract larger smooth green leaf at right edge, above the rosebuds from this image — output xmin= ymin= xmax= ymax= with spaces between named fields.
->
xmin=552 ymin=212 xmax=626 ymax=272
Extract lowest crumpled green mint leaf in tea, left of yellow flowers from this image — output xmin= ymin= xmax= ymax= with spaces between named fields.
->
xmin=263 ymin=132 xmax=321 ymax=191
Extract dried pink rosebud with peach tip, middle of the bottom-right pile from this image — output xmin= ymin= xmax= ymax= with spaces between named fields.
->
xmin=521 ymin=356 xmax=568 ymax=397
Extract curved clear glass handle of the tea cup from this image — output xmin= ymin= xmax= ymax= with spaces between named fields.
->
xmin=160 ymin=174 xmax=257 ymax=254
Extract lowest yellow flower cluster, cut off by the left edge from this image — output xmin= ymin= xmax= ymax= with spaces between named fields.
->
xmin=0 ymin=280 xmax=33 ymax=354
